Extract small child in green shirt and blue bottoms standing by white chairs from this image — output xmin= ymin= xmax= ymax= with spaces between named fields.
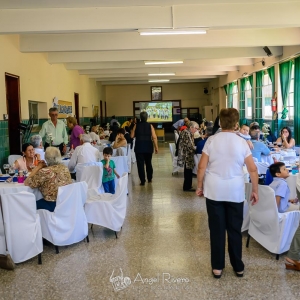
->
xmin=101 ymin=147 xmax=120 ymax=194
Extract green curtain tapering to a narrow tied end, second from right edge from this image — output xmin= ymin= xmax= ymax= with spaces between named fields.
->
xmin=279 ymin=60 xmax=293 ymax=119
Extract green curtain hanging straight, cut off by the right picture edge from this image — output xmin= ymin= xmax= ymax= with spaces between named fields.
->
xmin=294 ymin=57 xmax=300 ymax=145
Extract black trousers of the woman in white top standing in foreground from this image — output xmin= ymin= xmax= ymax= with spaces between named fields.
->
xmin=206 ymin=198 xmax=244 ymax=272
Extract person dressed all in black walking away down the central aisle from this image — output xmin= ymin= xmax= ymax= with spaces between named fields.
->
xmin=131 ymin=111 xmax=158 ymax=185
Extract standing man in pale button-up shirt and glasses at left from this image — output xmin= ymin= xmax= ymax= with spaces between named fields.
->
xmin=39 ymin=107 xmax=68 ymax=155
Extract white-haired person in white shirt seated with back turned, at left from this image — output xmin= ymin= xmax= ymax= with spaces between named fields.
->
xmin=68 ymin=134 xmax=100 ymax=172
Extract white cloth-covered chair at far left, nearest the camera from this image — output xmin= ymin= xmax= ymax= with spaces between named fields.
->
xmin=0 ymin=192 xmax=43 ymax=264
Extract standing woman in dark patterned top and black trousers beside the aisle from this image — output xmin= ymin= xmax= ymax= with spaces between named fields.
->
xmin=177 ymin=121 xmax=199 ymax=192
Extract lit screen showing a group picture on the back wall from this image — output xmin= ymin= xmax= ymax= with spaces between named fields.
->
xmin=140 ymin=101 xmax=172 ymax=123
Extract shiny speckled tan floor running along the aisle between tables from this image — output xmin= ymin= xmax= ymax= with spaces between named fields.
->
xmin=0 ymin=144 xmax=300 ymax=300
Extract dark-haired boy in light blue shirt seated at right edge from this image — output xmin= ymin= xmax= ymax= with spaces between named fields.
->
xmin=269 ymin=162 xmax=299 ymax=213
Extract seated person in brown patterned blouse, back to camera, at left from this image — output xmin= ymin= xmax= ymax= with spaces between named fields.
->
xmin=24 ymin=147 xmax=72 ymax=212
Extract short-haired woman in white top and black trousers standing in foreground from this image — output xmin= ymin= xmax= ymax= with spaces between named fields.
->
xmin=196 ymin=108 xmax=258 ymax=278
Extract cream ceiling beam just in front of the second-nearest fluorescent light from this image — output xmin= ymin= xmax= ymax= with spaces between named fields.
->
xmin=48 ymin=47 xmax=283 ymax=64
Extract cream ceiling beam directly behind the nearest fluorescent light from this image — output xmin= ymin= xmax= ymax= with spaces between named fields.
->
xmin=20 ymin=28 xmax=300 ymax=52
